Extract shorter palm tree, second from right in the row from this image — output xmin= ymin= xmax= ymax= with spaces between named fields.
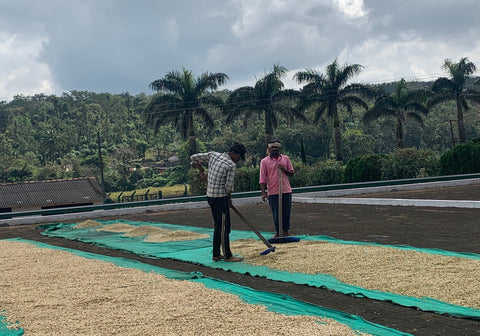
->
xmin=363 ymin=78 xmax=430 ymax=148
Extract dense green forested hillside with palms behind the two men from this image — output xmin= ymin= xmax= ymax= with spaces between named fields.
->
xmin=0 ymin=59 xmax=480 ymax=192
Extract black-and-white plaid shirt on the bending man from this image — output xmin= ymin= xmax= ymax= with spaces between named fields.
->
xmin=190 ymin=152 xmax=237 ymax=197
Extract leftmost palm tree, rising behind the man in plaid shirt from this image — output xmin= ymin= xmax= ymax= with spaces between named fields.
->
xmin=144 ymin=68 xmax=228 ymax=155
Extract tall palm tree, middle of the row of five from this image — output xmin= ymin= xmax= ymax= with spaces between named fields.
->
xmin=294 ymin=60 xmax=373 ymax=161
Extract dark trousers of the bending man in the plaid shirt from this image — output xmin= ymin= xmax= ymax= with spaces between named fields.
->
xmin=207 ymin=196 xmax=232 ymax=259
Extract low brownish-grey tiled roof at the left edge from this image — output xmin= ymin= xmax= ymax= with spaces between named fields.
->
xmin=0 ymin=178 xmax=103 ymax=208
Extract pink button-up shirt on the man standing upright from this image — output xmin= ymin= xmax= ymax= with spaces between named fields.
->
xmin=260 ymin=155 xmax=293 ymax=195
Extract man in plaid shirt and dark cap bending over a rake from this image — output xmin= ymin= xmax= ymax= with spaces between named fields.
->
xmin=190 ymin=143 xmax=246 ymax=262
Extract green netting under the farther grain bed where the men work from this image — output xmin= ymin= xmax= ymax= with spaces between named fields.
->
xmin=42 ymin=220 xmax=480 ymax=319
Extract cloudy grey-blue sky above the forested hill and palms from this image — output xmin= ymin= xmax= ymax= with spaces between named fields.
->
xmin=0 ymin=0 xmax=480 ymax=101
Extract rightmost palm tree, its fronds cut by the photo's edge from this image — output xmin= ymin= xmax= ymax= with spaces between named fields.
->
xmin=428 ymin=57 xmax=480 ymax=143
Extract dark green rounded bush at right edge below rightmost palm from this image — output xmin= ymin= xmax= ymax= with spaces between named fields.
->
xmin=440 ymin=138 xmax=480 ymax=175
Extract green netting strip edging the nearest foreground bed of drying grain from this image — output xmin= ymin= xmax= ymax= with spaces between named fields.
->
xmin=0 ymin=238 xmax=410 ymax=336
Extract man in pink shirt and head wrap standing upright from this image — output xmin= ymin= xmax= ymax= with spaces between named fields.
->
xmin=260 ymin=140 xmax=295 ymax=238
